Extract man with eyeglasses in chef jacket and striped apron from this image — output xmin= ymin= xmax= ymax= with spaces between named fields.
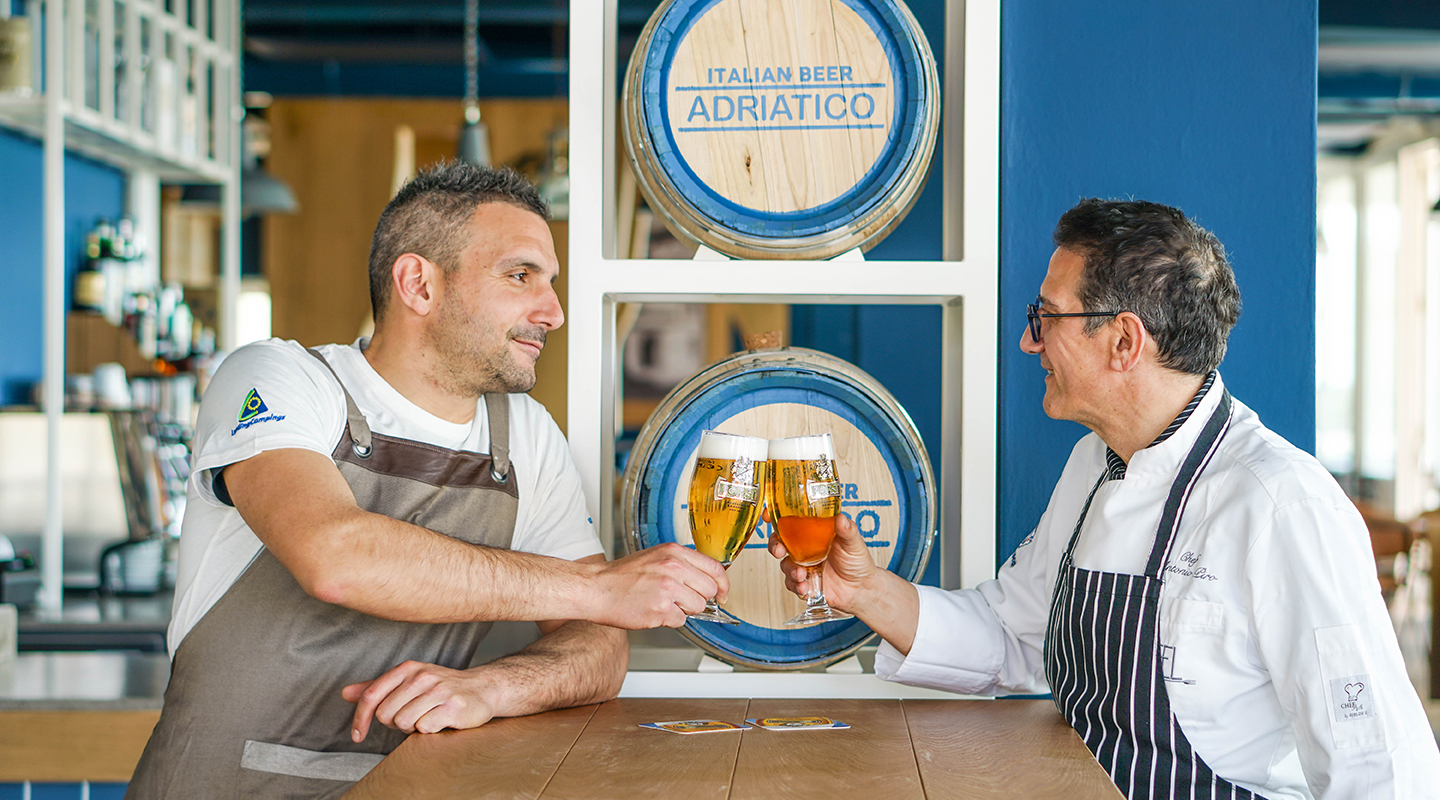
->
xmin=770 ymin=199 xmax=1440 ymax=800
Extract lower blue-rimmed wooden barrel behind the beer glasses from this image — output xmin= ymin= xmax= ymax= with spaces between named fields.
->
xmin=622 ymin=348 xmax=936 ymax=669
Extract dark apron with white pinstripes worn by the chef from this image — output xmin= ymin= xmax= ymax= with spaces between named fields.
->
xmin=1045 ymin=391 xmax=1257 ymax=800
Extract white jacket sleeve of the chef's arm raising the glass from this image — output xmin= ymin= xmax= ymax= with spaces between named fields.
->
xmin=876 ymin=515 xmax=1066 ymax=695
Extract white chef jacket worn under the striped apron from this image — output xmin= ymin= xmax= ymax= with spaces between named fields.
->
xmin=876 ymin=377 xmax=1440 ymax=800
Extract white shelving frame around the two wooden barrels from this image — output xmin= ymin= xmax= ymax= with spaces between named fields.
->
xmin=567 ymin=0 xmax=999 ymax=587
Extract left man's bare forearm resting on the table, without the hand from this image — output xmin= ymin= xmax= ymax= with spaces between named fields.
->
xmin=475 ymin=620 xmax=629 ymax=717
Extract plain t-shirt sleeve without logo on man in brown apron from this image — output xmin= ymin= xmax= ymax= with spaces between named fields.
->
xmin=510 ymin=394 xmax=605 ymax=561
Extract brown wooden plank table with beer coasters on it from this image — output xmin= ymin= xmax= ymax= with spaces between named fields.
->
xmin=346 ymin=698 xmax=1120 ymax=800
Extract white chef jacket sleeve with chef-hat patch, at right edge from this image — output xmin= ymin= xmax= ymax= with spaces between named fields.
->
xmin=1246 ymin=498 xmax=1440 ymax=800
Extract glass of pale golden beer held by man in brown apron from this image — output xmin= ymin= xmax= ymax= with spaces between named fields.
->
xmin=688 ymin=430 xmax=770 ymax=624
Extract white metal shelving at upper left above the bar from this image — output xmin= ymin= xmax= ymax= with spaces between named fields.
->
xmin=0 ymin=0 xmax=243 ymax=609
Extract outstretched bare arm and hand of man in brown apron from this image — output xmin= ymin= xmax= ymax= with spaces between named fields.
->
xmin=234 ymin=449 xmax=726 ymax=629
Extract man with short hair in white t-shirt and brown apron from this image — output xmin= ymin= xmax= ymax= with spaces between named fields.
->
xmin=128 ymin=163 xmax=729 ymax=799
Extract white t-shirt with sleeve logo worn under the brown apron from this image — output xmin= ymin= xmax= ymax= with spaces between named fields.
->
xmin=168 ymin=338 xmax=602 ymax=653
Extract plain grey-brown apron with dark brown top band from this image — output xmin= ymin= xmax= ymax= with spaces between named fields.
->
xmin=125 ymin=351 xmax=520 ymax=800
